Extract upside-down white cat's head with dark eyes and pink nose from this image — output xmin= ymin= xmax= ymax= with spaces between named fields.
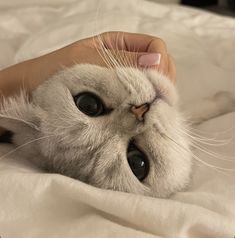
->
xmin=0 ymin=64 xmax=191 ymax=197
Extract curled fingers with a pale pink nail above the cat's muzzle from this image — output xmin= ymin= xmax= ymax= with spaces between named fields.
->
xmin=83 ymin=32 xmax=176 ymax=82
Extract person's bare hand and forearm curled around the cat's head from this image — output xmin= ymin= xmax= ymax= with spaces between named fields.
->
xmin=0 ymin=32 xmax=176 ymax=134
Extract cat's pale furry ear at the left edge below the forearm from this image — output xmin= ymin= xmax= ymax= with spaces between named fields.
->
xmin=0 ymin=92 xmax=38 ymax=135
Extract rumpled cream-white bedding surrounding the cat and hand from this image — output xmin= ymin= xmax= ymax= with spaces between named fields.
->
xmin=0 ymin=0 xmax=235 ymax=238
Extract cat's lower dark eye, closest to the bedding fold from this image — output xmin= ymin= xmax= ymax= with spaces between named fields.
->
xmin=127 ymin=146 xmax=149 ymax=181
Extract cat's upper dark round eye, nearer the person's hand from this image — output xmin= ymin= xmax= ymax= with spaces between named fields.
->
xmin=75 ymin=93 xmax=104 ymax=116
